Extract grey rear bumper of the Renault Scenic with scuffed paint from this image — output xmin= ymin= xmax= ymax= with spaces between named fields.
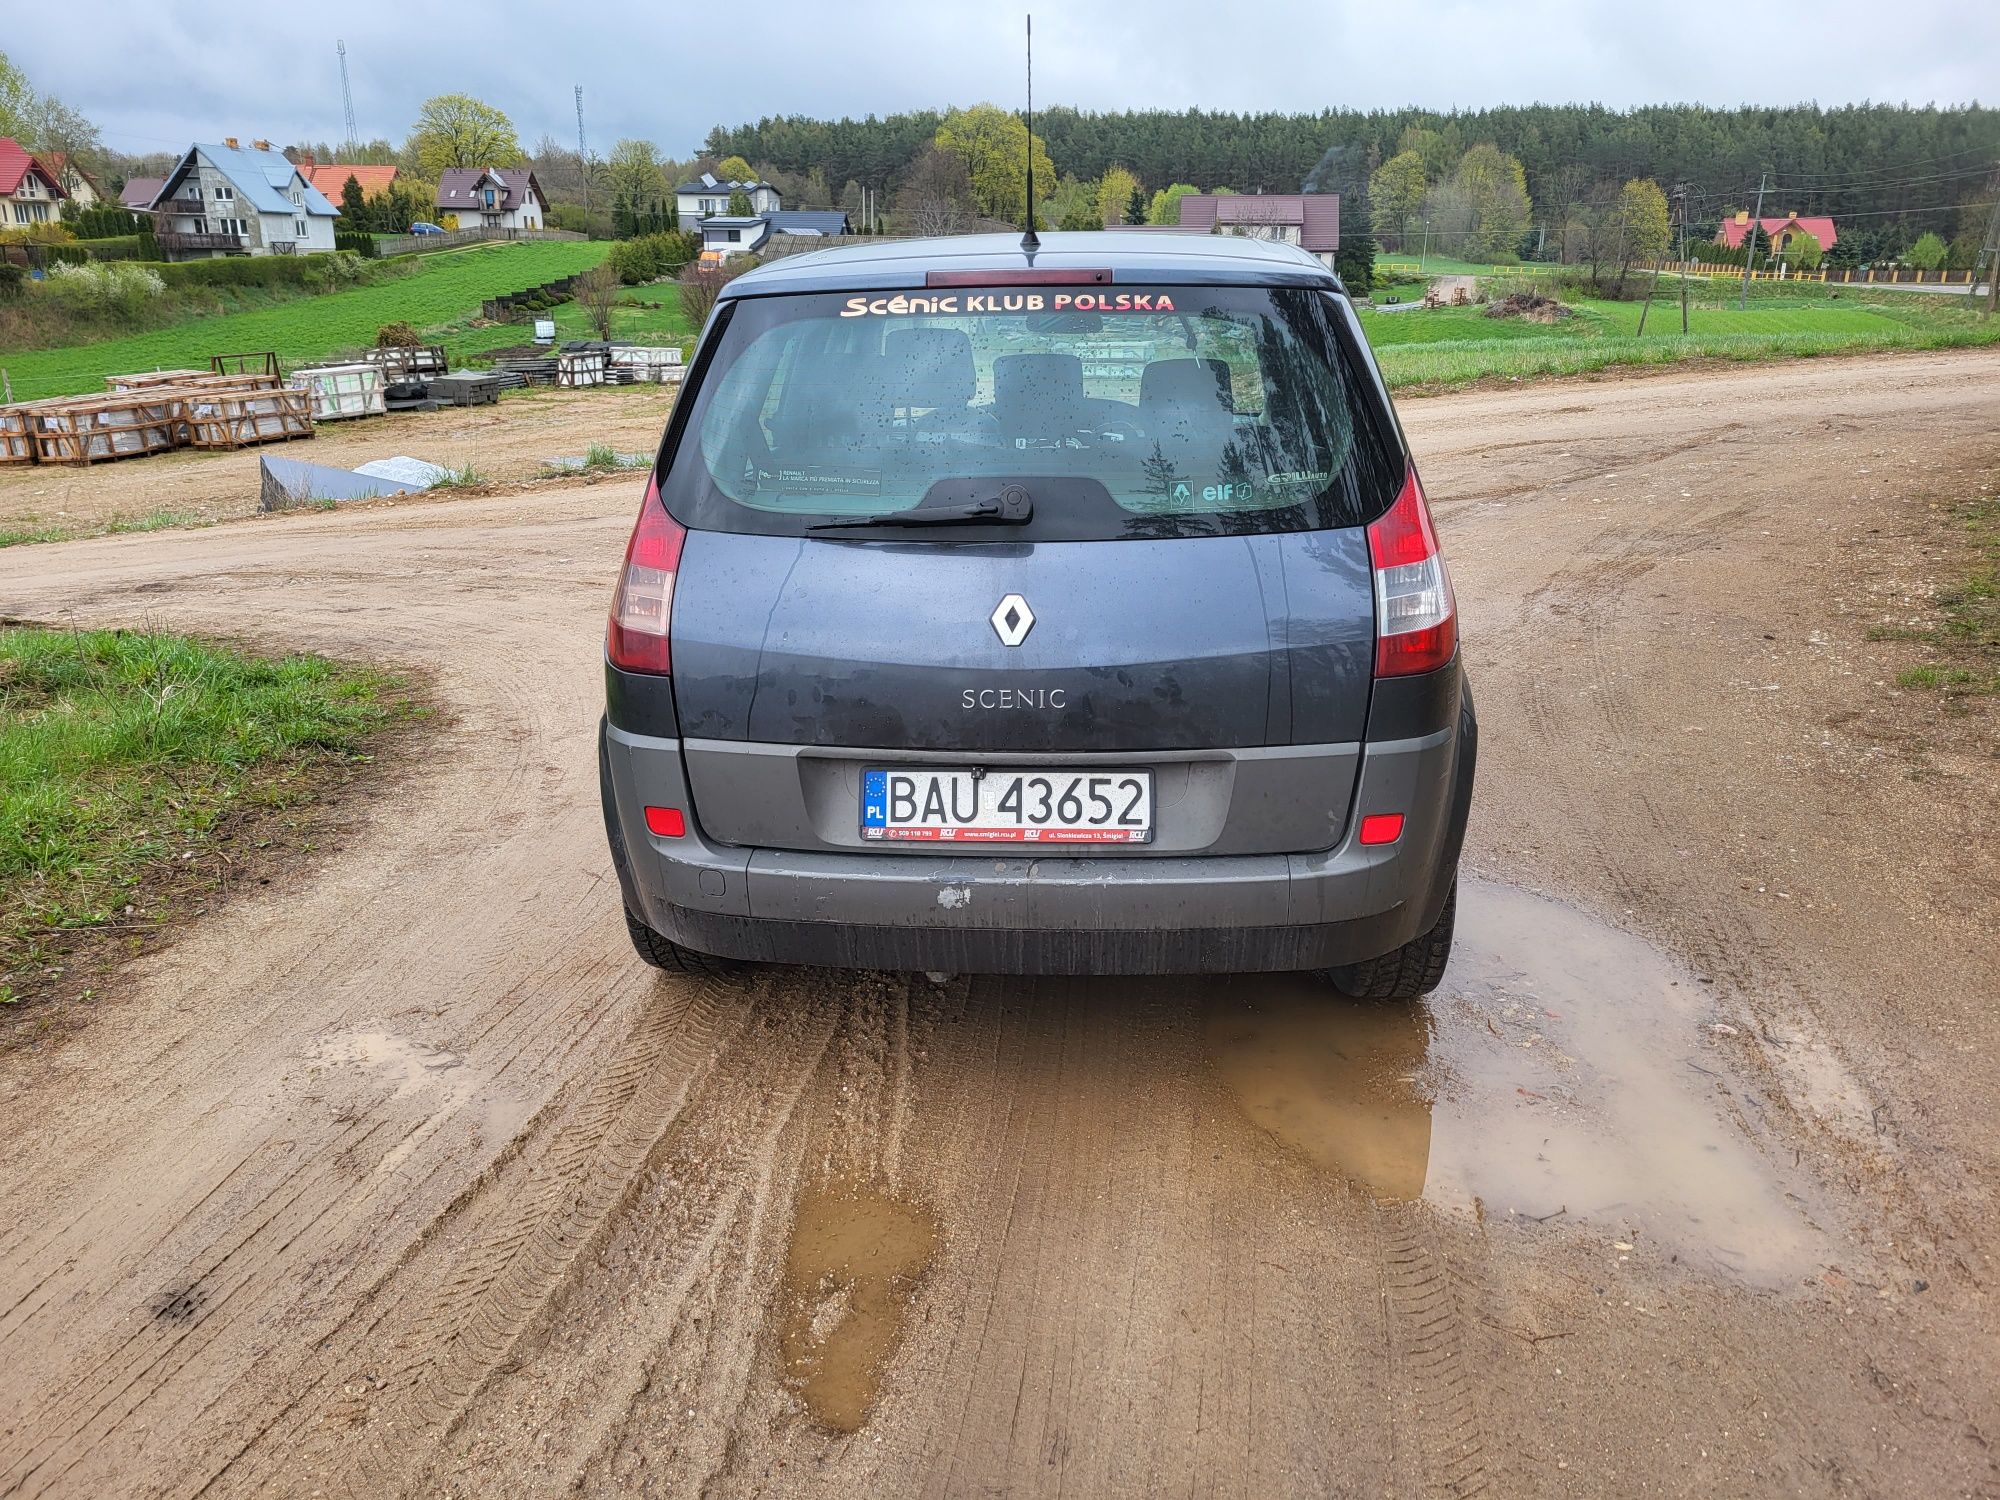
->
xmin=600 ymin=676 xmax=1476 ymax=974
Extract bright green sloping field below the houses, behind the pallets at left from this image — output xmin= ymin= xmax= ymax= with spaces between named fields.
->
xmin=0 ymin=240 xmax=608 ymax=400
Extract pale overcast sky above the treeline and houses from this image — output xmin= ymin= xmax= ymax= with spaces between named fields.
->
xmin=0 ymin=0 xmax=2000 ymax=156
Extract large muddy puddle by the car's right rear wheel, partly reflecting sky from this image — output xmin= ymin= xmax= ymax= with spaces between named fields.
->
xmin=1206 ymin=884 xmax=1826 ymax=1286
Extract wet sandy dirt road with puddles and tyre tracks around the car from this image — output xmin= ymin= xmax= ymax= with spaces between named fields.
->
xmin=0 ymin=354 xmax=2000 ymax=1498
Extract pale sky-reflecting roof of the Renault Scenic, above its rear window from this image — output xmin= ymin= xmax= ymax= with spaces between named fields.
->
xmin=720 ymin=230 xmax=1344 ymax=298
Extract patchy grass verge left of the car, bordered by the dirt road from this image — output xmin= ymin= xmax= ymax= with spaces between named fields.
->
xmin=0 ymin=624 xmax=426 ymax=1030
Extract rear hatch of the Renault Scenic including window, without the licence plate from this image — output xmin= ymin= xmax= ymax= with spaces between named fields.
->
xmin=624 ymin=288 xmax=1406 ymax=858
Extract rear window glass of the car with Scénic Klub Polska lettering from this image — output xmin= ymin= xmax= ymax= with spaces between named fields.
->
xmin=662 ymin=286 xmax=1402 ymax=540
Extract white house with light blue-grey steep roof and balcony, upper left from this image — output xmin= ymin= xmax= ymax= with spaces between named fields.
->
xmin=152 ymin=136 xmax=340 ymax=260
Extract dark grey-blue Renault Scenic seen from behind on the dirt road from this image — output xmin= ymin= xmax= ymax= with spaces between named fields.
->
xmin=600 ymin=232 xmax=1476 ymax=998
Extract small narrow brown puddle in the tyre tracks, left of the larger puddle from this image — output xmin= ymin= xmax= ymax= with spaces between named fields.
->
xmin=778 ymin=1184 xmax=938 ymax=1432
